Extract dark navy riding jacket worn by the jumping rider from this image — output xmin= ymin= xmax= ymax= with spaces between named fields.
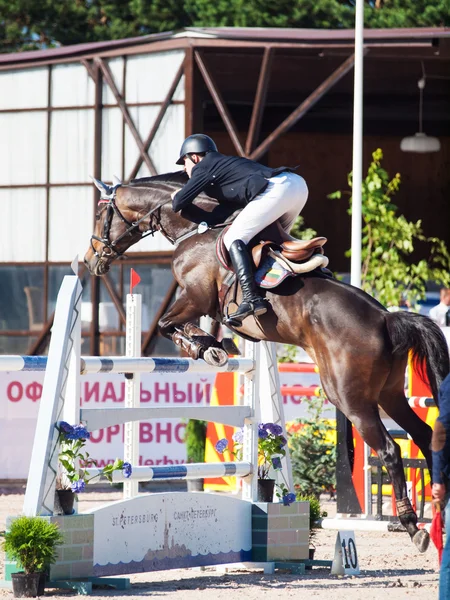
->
xmin=173 ymin=152 xmax=294 ymax=212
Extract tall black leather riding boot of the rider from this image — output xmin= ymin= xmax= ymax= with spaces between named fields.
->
xmin=225 ymin=240 xmax=268 ymax=327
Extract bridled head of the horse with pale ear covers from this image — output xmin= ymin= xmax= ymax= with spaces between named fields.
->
xmin=84 ymin=179 xmax=156 ymax=275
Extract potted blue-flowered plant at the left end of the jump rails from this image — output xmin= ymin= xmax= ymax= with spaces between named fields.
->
xmin=56 ymin=421 xmax=132 ymax=515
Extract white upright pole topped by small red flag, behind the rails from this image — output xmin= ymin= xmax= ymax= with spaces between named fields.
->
xmin=123 ymin=294 xmax=142 ymax=500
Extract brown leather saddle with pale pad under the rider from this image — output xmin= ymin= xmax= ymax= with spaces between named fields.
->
xmin=216 ymin=222 xmax=328 ymax=288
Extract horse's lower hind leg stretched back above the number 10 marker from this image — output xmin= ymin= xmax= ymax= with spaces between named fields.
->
xmin=349 ymin=407 xmax=430 ymax=552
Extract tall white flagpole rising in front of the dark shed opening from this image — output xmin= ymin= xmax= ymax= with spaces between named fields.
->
xmin=350 ymin=0 xmax=364 ymax=287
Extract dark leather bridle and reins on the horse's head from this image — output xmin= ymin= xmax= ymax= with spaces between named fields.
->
xmin=91 ymin=185 xmax=174 ymax=260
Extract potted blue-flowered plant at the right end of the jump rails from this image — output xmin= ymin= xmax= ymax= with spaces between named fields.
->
xmin=216 ymin=423 xmax=287 ymax=502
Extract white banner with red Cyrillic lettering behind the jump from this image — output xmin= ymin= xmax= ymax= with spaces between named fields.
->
xmin=0 ymin=372 xmax=326 ymax=479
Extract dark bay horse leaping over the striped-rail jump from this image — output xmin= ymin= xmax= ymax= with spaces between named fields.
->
xmin=85 ymin=173 xmax=450 ymax=552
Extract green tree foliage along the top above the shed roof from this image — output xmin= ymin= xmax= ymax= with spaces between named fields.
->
xmin=0 ymin=0 xmax=450 ymax=52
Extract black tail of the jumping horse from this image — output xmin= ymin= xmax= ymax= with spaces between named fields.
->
xmin=386 ymin=311 xmax=450 ymax=404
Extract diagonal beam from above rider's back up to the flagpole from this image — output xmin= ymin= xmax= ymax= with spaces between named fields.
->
xmin=249 ymin=54 xmax=355 ymax=160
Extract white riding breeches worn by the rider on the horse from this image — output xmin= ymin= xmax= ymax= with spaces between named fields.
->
xmin=223 ymin=172 xmax=308 ymax=250
